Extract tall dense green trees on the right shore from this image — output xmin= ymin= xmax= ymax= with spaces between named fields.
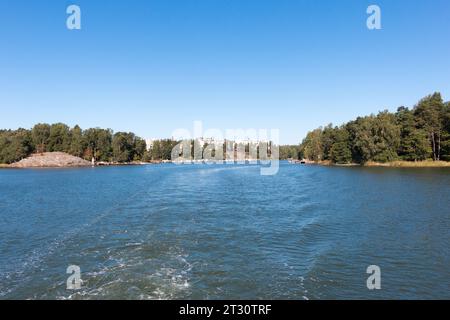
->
xmin=299 ymin=93 xmax=450 ymax=164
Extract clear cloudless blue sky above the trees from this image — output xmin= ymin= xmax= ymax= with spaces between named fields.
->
xmin=0 ymin=0 xmax=450 ymax=143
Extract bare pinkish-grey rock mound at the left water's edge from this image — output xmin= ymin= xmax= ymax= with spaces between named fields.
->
xmin=10 ymin=152 xmax=92 ymax=168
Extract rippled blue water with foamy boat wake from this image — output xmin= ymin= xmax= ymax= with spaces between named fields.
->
xmin=0 ymin=163 xmax=450 ymax=299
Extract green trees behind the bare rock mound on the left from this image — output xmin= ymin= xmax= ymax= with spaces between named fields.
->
xmin=0 ymin=123 xmax=177 ymax=164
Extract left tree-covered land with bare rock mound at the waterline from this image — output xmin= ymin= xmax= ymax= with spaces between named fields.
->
xmin=0 ymin=123 xmax=178 ymax=168
